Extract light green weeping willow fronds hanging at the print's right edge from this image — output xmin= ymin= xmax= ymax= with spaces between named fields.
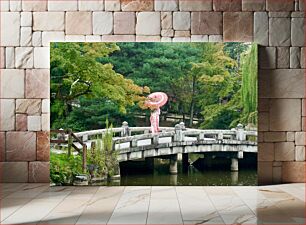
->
xmin=241 ymin=45 xmax=258 ymax=125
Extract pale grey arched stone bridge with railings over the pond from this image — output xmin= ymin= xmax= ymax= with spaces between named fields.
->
xmin=76 ymin=122 xmax=257 ymax=173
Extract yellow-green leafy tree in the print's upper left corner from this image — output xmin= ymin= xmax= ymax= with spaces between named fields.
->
xmin=51 ymin=43 xmax=149 ymax=129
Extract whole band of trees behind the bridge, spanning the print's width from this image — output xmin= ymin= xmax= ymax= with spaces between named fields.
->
xmin=51 ymin=43 xmax=257 ymax=131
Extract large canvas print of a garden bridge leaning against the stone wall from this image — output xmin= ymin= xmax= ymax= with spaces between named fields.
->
xmin=50 ymin=43 xmax=258 ymax=186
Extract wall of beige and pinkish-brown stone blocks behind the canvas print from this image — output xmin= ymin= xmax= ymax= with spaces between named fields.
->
xmin=0 ymin=0 xmax=306 ymax=184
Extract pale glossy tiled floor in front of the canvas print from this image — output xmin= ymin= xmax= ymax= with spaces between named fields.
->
xmin=0 ymin=184 xmax=306 ymax=224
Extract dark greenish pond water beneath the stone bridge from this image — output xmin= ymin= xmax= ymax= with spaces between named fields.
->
xmin=96 ymin=160 xmax=257 ymax=186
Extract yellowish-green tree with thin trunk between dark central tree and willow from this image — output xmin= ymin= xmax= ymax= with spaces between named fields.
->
xmin=177 ymin=44 xmax=236 ymax=127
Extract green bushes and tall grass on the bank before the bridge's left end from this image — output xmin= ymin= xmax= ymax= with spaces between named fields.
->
xmin=50 ymin=123 xmax=119 ymax=185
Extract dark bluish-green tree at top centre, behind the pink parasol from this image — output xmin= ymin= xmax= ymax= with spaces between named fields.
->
xmin=99 ymin=43 xmax=202 ymax=122
